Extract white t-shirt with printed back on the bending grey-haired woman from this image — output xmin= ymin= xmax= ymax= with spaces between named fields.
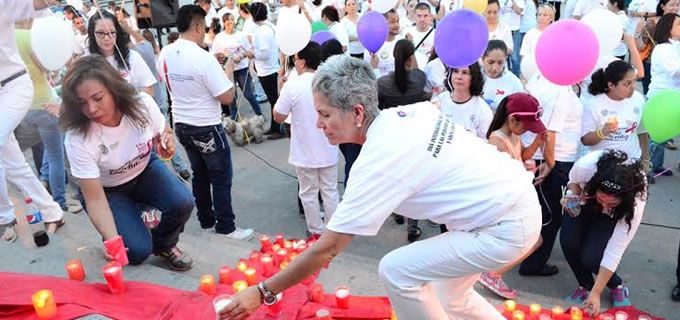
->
xmin=327 ymin=102 xmax=536 ymax=236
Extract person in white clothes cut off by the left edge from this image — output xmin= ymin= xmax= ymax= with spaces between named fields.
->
xmin=0 ymin=0 xmax=64 ymax=242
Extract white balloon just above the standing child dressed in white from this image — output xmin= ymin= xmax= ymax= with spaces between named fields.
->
xmin=276 ymin=12 xmax=312 ymax=56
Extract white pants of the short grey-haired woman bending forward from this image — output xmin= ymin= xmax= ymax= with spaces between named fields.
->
xmin=379 ymin=191 xmax=541 ymax=320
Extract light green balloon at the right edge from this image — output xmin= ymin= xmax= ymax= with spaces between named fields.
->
xmin=642 ymin=90 xmax=680 ymax=143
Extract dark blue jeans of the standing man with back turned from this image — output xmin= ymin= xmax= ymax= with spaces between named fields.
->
xmin=175 ymin=123 xmax=236 ymax=234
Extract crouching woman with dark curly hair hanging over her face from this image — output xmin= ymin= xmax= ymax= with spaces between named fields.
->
xmin=560 ymin=150 xmax=647 ymax=313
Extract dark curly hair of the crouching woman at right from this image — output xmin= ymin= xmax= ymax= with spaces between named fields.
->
xmin=583 ymin=150 xmax=647 ymax=231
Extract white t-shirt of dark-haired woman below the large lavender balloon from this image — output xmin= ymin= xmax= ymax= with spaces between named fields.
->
xmin=437 ymin=91 xmax=493 ymax=140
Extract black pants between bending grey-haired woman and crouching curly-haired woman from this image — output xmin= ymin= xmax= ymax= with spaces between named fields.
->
xmin=520 ymin=161 xmax=574 ymax=273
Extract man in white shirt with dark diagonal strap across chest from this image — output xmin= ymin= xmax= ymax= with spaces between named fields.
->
xmin=405 ymin=2 xmax=434 ymax=70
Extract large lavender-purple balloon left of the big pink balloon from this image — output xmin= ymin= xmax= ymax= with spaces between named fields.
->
xmin=434 ymin=9 xmax=489 ymax=68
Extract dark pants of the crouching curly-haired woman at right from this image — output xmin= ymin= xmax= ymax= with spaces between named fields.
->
xmin=560 ymin=205 xmax=623 ymax=290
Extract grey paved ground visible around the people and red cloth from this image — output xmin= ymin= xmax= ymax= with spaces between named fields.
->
xmin=0 ymin=101 xmax=680 ymax=319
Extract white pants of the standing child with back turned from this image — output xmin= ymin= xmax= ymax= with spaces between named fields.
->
xmin=295 ymin=166 xmax=340 ymax=234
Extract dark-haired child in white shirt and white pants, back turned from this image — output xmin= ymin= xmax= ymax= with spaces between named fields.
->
xmin=274 ymin=42 xmax=339 ymax=236
